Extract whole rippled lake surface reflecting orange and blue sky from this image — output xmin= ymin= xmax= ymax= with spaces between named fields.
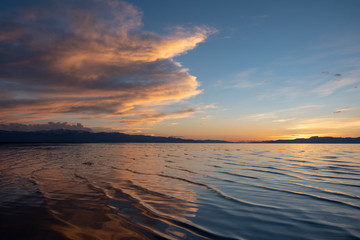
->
xmin=0 ymin=143 xmax=360 ymax=240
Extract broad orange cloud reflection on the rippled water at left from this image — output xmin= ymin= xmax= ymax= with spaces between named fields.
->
xmin=28 ymin=144 xmax=198 ymax=240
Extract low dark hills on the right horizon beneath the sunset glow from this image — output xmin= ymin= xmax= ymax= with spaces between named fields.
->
xmin=254 ymin=136 xmax=360 ymax=143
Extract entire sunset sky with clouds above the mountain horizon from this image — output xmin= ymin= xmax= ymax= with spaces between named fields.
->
xmin=0 ymin=0 xmax=360 ymax=141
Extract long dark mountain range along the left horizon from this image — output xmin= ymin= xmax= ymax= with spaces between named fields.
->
xmin=0 ymin=129 xmax=231 ymax=143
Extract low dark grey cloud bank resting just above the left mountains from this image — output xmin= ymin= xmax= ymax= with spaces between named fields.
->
xmin=0 ymin=122 xmax=92 ymax=132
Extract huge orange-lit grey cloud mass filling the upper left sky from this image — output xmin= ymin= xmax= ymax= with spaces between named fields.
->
xmin=0 ymin=0 xmax=215 ymax=127
